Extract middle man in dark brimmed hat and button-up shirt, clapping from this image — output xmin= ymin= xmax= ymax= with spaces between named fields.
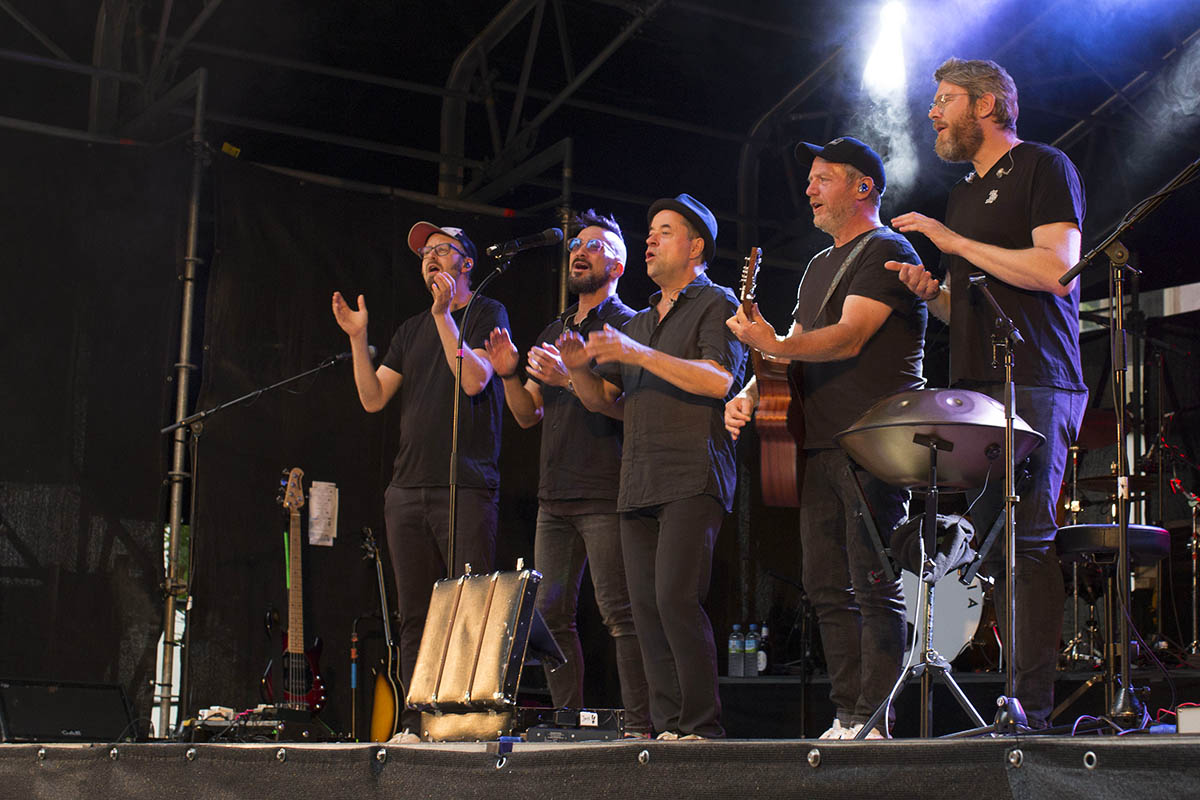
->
xmin=559 ymin=194 xmax=746 ymax=739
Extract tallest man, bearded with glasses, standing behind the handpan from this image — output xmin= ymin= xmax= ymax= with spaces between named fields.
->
xmin=887 ymin=59 xmax=1087 ymax=728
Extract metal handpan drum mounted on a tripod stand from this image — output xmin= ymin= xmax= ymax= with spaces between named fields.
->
xmin=834 ymin=389 xmax=1043 ymax=738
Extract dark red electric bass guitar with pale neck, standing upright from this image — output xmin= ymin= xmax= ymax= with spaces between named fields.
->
xmin=262 ymin=467 xmax=325 ymax=716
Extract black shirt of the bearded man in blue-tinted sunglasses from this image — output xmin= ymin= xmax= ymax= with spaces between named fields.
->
xmin=534 ymin=296 xmax=634 ymax=515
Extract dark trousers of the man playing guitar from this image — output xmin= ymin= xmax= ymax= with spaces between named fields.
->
xmin=800 ymin=450 xmax=908 ymax=726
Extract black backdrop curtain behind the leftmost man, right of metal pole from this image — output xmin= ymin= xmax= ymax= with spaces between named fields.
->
xmin=190 ymin=153 xmax=557 ymax=733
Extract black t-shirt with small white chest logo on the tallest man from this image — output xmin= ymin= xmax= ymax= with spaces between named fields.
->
xmin=942 ymin=142 xmax=1086 ymax=391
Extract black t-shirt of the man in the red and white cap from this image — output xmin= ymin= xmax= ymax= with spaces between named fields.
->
xmin=383 ymin=296 xmax=509 ymax=489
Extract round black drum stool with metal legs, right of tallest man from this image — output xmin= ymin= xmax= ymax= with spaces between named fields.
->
xmin=1050 ymin=523 xmax=1171 ymax=721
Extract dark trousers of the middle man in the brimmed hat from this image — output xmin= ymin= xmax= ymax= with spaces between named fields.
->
xmin=620 ymin=494 xmax=725 ymax=738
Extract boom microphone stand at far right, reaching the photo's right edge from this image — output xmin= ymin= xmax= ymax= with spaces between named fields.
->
xmin=1058 ymin=151 xmax=1200 ymax=726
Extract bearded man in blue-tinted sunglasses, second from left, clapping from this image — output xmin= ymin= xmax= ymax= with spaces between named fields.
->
xmin=487 ymin=210 xmax=650 ymax=738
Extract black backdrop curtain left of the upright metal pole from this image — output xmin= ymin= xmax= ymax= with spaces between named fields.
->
xmin=0 ymin=131 xmax=190 ymax=716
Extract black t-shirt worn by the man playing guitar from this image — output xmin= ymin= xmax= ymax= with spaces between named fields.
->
xmin=790 ymin=228 xmax=926 ymax=450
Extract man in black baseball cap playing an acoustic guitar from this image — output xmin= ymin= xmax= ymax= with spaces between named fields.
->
xmin=725 ymin=137 xmax=926 ymax=739
